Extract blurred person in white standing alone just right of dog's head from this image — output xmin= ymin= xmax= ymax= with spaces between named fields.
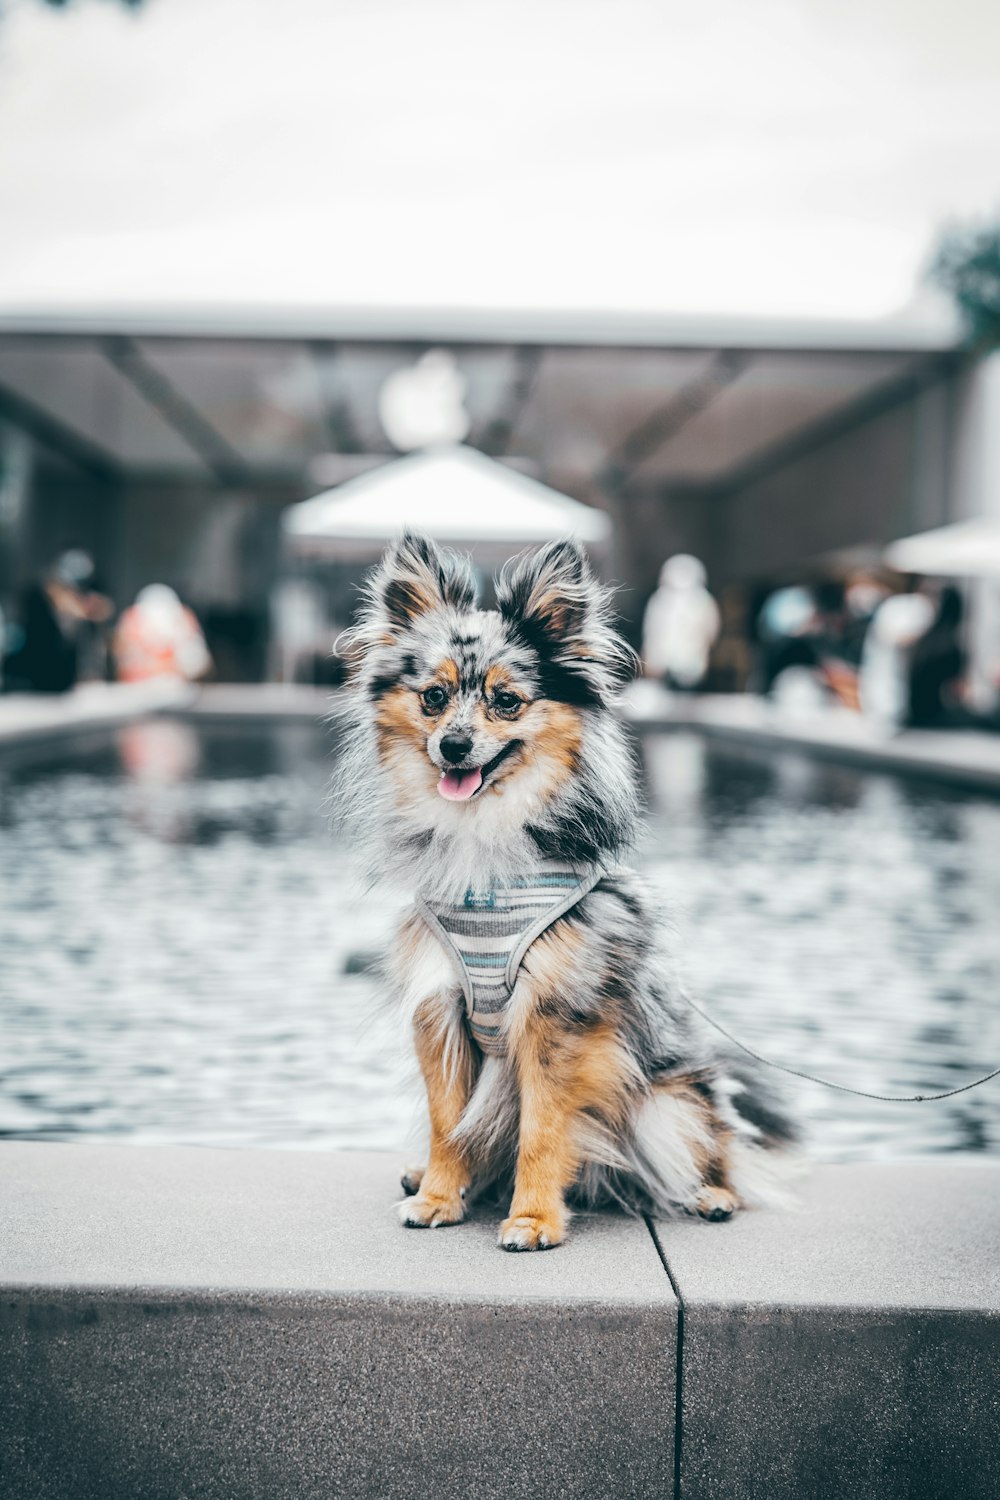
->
xmin=642 ymin=552 xmax=721 ymax=692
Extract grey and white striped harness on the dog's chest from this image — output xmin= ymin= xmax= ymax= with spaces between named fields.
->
xmin=417 ymin=860 xmax=604 ymax=1056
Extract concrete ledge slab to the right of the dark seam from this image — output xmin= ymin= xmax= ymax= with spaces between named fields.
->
xmin=657 ymin=1158 xmax=1000 ymax=1500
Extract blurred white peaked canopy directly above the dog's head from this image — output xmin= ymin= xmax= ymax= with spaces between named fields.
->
xmin=283 ymin=447 xmax=612 ymax=560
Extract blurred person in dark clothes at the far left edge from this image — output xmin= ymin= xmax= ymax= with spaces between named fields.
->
xmin=3 ymin=548 xmax=114 ymax=693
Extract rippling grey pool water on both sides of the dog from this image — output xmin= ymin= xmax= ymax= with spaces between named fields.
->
xmin=0 ymin=720 xmax=1000 ymax=1158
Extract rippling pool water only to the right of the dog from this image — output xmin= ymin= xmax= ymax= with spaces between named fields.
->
xmin=643 ymin=737 xmax=1000 ymax=1157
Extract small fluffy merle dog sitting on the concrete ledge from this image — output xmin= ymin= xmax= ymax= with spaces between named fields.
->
xmin=339 ymin=534 xmax=792 ymax=1250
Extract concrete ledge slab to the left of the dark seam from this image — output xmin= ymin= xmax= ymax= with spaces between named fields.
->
xmin=0 ymin=1143 xmax=676 ymax=1500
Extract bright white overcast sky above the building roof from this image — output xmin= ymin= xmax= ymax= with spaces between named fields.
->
xmin=0 ymin=0 xmax=1000 ymax=318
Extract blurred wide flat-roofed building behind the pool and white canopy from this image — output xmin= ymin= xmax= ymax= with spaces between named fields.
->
xmin=0 ymin=312 xmax=1000 ymax=678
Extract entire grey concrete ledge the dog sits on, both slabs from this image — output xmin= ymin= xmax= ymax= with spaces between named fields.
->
xmin=0 ymin=1143 xmax=1000 ymax=1500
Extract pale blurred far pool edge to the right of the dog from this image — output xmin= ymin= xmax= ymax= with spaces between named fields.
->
xmin=622 ymin=681 xmax=1000 ymax=792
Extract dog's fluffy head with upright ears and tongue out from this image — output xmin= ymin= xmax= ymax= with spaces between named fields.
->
xmin=351 ymin=534 xmax=633 ymax=828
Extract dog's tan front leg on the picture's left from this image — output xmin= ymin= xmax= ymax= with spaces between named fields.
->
xmin=399 ymin=998 xmax=478 ymax=1229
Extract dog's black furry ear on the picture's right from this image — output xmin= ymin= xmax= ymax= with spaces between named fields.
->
xmin=496 ymin=540 xmax=636 ymax=704
